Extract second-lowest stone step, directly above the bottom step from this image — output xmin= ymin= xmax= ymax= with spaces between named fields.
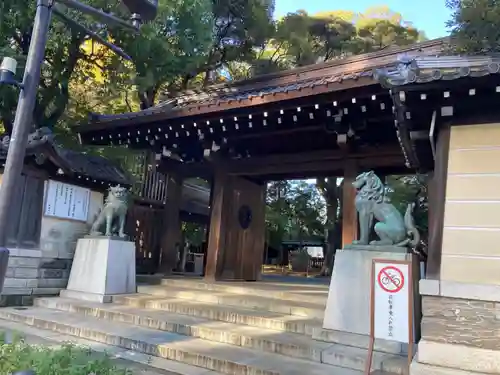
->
xmin=35 ymin=297 xmax=331 ymax=363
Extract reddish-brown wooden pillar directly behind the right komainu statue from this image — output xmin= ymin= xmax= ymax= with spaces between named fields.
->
xmin=342 ymin=160 xmax=358 ymax=247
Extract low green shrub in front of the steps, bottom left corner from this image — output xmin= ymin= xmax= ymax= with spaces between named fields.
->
xmin=0 ymin=333 xmax=131 ymax=375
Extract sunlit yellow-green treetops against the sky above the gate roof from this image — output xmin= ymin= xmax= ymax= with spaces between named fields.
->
xmin=255 ymin=6 xmax=425 ymax=73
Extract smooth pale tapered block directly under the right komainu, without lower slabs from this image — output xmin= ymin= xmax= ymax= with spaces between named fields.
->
xmin=323 ymin=246 xmax=412 ymax=335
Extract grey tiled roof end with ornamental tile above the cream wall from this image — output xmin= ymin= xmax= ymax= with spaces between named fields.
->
xmin=374 ymin=56 xmax=500 ymax=87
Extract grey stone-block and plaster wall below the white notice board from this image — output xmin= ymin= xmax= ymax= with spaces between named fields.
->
xmin=0 ymin=184 xmax=103 ymax=306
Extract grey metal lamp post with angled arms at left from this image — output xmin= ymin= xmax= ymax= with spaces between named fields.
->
xmin=0 ymin=0 xmax=158 ymax=250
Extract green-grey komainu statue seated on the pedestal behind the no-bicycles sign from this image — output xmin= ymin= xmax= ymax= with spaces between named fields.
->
xmin=352 ymin=171 xmax=420 ymax=247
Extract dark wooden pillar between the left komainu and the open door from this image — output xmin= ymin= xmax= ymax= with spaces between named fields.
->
xmin=159 ymin=173 xmax=182 ymax=274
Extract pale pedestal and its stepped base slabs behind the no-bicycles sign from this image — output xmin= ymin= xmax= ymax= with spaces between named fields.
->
xmin=314 ymin=245 xmax=420 ymax=373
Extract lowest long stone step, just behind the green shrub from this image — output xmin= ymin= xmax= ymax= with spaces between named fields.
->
xmin=0 ymin=307 xmax=362 ymax=375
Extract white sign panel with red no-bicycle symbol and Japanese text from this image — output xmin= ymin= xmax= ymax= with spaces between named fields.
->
xmin=373 ymin=261 xmax=411 ymax=343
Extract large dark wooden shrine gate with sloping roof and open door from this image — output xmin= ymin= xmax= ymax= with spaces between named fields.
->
xmin=78 ymin=40 xmax=444 ymax=280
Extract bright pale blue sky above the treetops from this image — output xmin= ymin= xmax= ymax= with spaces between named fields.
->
xmin=275 ymin=0 xmax=450 ymax=39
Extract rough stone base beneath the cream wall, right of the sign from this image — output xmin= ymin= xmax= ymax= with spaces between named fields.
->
xmin=410 ymin=296 xmax=500 ymax=375
